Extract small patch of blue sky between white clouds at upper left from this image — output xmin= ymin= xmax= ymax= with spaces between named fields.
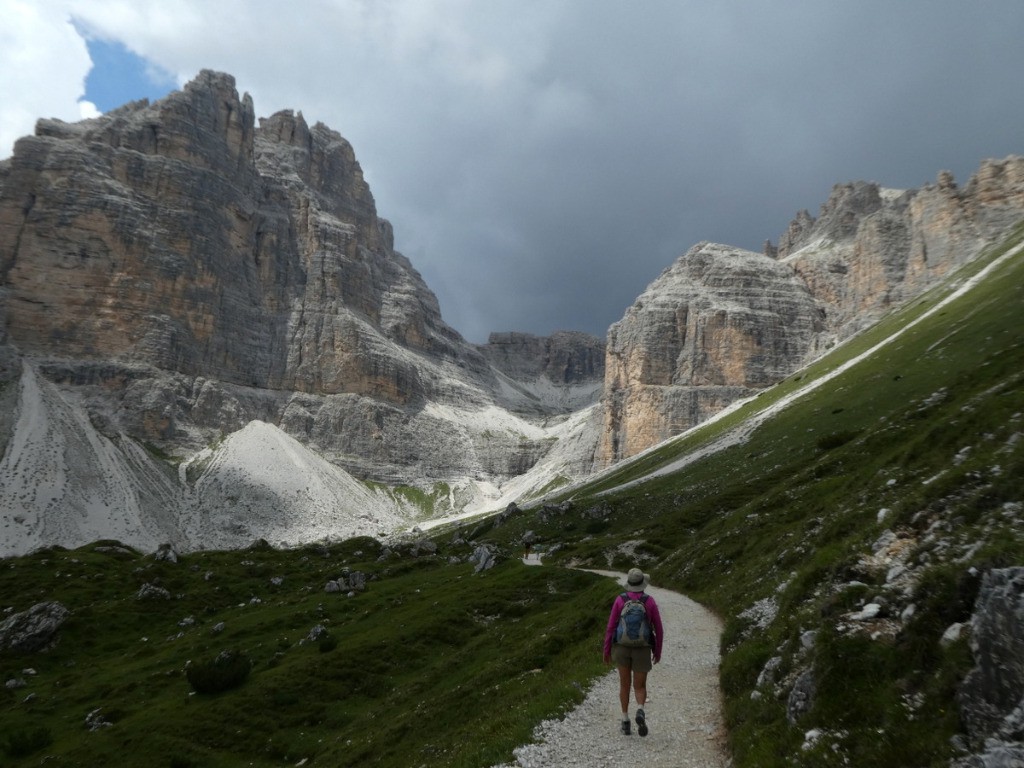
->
xmin=84 ymin=40 xmax=177 ymax=112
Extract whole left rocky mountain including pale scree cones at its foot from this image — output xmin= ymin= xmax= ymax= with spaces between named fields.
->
xmin=0 ymin=72 xmax=603 ymax=553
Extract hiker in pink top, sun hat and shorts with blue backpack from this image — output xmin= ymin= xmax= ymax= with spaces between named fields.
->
xmin=604 ymin=568 xmax=665 ymax=736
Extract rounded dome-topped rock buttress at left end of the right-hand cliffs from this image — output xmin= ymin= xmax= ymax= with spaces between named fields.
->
xmin=600 ymin=243 xmax=822 ymax=464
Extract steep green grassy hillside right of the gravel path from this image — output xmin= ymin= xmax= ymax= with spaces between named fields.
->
xmin=462 ymin=228 xmax=1024 ymax=768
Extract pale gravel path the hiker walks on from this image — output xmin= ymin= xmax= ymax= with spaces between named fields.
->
xmin=495 ymin=560 xmax=729 ymax=768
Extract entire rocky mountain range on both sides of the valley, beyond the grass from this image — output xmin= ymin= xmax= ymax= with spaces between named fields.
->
xmin=0 ymin=71 xmax=1024 ymax=552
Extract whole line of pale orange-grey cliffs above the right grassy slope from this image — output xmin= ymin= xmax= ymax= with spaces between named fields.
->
xmin=598 ymin=157 xmax=1024 ymax=465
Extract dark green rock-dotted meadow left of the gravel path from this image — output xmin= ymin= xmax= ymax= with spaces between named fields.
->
xmin=0 ymin=540 xmax=614 ymax=768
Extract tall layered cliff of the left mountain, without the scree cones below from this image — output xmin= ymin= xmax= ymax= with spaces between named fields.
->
xmin=0 ymin=72 xmax=600 ymax=518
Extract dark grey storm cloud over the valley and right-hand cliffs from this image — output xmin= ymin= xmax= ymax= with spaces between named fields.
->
xmin=342 ymin=3 xmax=1024 ymax=340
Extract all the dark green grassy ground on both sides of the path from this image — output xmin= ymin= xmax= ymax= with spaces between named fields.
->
xmin=0 ymin=224 xmax=1024 ymax=766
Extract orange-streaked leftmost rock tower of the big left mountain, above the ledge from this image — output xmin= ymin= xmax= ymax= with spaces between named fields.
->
xmin=0 ymin=72 xmax=268 ymax=384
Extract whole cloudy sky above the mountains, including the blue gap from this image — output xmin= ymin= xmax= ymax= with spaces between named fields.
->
xmin=0 ymin=0 xmax=1024 ymax=342
